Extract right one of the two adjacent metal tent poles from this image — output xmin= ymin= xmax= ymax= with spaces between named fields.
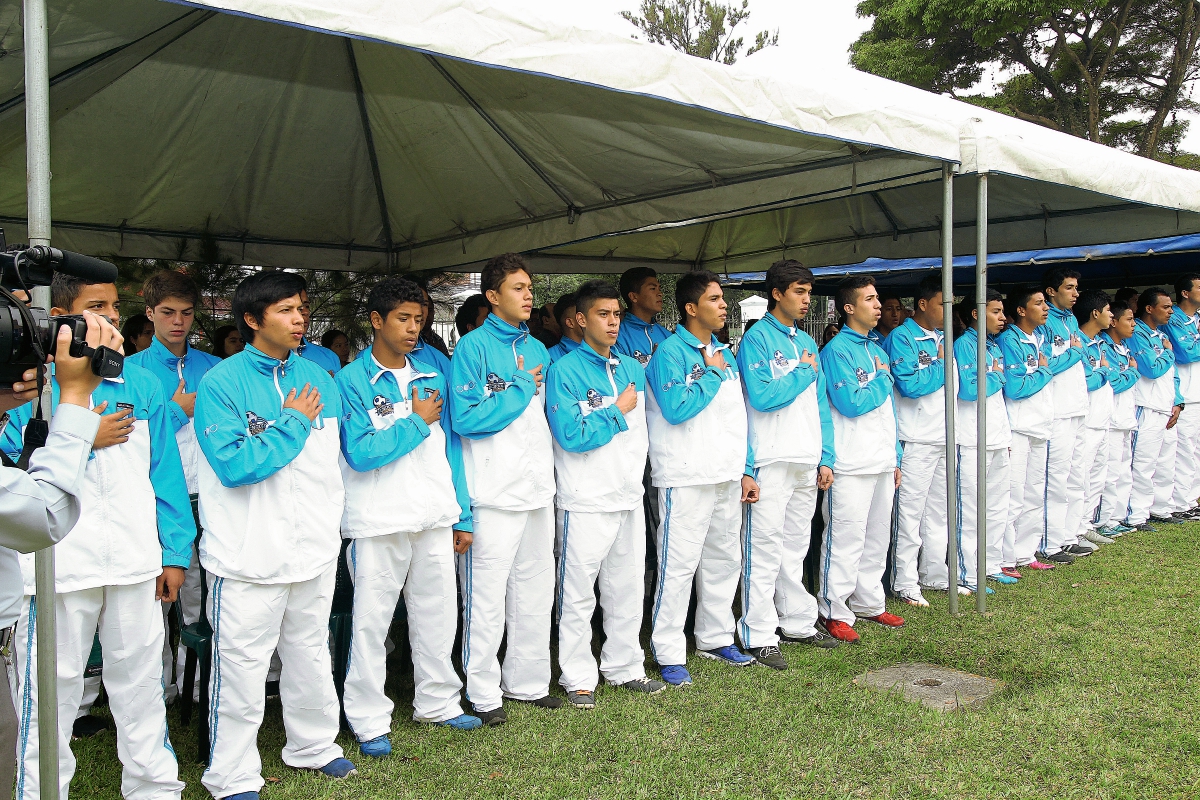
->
xmin=968 ymin=173 xmax=988 ymax=614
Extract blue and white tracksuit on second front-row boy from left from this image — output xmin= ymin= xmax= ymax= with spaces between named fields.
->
xmin=196 ymin=344 xmax=346 ymax=798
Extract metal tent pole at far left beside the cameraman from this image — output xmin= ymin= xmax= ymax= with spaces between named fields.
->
xmin=24 ymin=0 xmax=59 ymax=800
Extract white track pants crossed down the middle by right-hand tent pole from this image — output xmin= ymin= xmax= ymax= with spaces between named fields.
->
xmin=950 ymin=446 xmax=1012 ymax=588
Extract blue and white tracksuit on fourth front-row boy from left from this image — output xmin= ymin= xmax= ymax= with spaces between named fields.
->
xmin=449 ymin=314 xmax=554 ymax=711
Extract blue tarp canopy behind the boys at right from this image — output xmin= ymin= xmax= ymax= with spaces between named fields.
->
xmin=726 ymin=234 xmax=1200 ymax=294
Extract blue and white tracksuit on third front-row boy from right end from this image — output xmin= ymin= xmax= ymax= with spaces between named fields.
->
xmin=1093 ymin=332 xmax=1139 ymax=533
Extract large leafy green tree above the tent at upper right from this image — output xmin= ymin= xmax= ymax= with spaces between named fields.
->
xmin=851 ymin=0 xmax=1200 ymax=158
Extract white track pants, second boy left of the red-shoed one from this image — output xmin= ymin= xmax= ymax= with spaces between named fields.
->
xmin=650 ymin=480 xmax=742 ymax=666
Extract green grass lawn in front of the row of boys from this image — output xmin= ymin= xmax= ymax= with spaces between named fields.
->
xmin=72 ymin=524 xmax=1200 ymax=800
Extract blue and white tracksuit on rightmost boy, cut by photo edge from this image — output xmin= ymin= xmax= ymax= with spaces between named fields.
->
xmin=1163 ymin=306 xmax=1200 ymax=511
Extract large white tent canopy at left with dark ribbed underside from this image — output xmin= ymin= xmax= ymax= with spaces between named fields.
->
xmin=0 ymin=0 xmax=959 ymax=269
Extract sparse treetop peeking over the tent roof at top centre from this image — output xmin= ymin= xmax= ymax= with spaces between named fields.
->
xmin=620 ymin=0 xmax=779 ymax=64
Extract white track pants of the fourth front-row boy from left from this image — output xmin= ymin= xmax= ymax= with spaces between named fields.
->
xmin=458 ymin=506 xmax=554 ymax=711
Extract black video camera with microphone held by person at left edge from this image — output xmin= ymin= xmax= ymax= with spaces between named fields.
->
xmin=0 ymin=229 xmax=125 ymax=389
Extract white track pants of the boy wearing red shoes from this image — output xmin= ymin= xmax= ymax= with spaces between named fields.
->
xmin=817 ymin=469 xmax=902 ymax=625
